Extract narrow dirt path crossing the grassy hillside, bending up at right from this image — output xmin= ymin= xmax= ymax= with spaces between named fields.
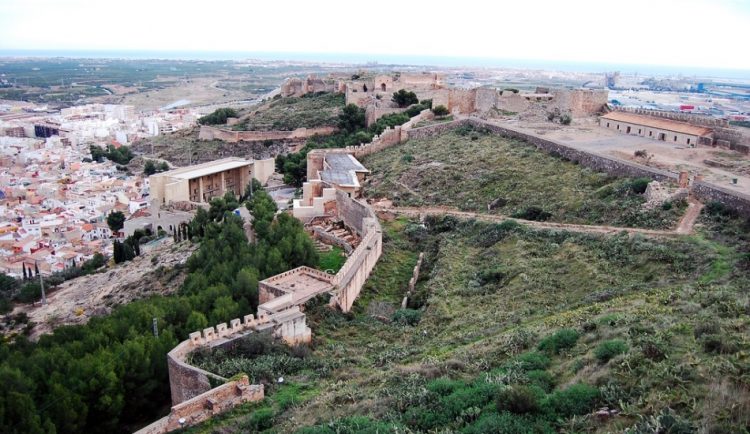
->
xmin=373 ymin=203 xmax=703 ymax=237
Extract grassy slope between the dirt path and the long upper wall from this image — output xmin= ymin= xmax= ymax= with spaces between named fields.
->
xmin=362 ymin=127 xmax=685 ymax=229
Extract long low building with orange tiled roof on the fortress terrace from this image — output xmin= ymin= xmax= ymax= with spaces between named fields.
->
xmin=599 ymin=112 xmax=713 ymax=146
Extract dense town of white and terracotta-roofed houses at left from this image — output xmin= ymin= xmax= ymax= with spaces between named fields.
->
xmin=0 ymin=104 xmax=196 ymax=278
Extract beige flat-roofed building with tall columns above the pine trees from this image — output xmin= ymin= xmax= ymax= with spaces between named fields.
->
xmin=148 ymin=157 xmax=274 ymax=205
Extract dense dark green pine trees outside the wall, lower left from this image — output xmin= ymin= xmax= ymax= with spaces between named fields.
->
xmin=0 ymin=184 xmax=317 ymax=434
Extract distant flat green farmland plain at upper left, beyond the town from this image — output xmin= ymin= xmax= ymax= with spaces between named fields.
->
xmin=0 ymin=57 xmax=326 ymax=109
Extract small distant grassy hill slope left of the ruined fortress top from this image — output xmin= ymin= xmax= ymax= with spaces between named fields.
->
xmin=234 ymin=93 xmax=345 ymax=131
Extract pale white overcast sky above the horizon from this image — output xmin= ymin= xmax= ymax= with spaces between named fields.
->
xmin=0 ymin=0 xmax=750 ymax=70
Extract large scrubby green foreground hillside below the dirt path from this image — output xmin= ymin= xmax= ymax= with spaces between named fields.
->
xmin=187 ymin=204 xmax=750 ymax=434
